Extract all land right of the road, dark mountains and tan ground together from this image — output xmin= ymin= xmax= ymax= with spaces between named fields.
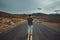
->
xmin=32 ymin=13 xmax=60 ymax=29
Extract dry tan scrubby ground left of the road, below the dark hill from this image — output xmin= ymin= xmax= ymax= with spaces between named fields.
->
xmin=0 ymin=17 xmax=25 ymax=33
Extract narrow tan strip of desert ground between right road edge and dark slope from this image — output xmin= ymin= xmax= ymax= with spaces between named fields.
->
xmin=36 ymin=18 xmax=60 ymax=29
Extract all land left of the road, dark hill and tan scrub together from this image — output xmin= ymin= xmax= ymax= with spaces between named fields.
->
xmin=0 ymin=12 xmax=26 ymax=33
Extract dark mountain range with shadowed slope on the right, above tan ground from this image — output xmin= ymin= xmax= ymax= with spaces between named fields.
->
xmin=32 ymin=13 xmax=60 ymax=22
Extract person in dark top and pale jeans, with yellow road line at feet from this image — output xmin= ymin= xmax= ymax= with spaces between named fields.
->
xmin=27 ymin=15 xmax=33 ymax=40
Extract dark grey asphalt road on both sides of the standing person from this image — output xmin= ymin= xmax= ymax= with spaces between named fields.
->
xmin=0 ymin=22 xmax=60 ymax=40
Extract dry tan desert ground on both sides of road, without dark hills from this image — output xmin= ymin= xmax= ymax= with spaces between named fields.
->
xmin=0 ymin=17 xmax=60 ymax=33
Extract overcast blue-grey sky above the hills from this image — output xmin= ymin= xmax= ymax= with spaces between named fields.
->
xmin=0 ymin=0 xmax=60 ymax=14
